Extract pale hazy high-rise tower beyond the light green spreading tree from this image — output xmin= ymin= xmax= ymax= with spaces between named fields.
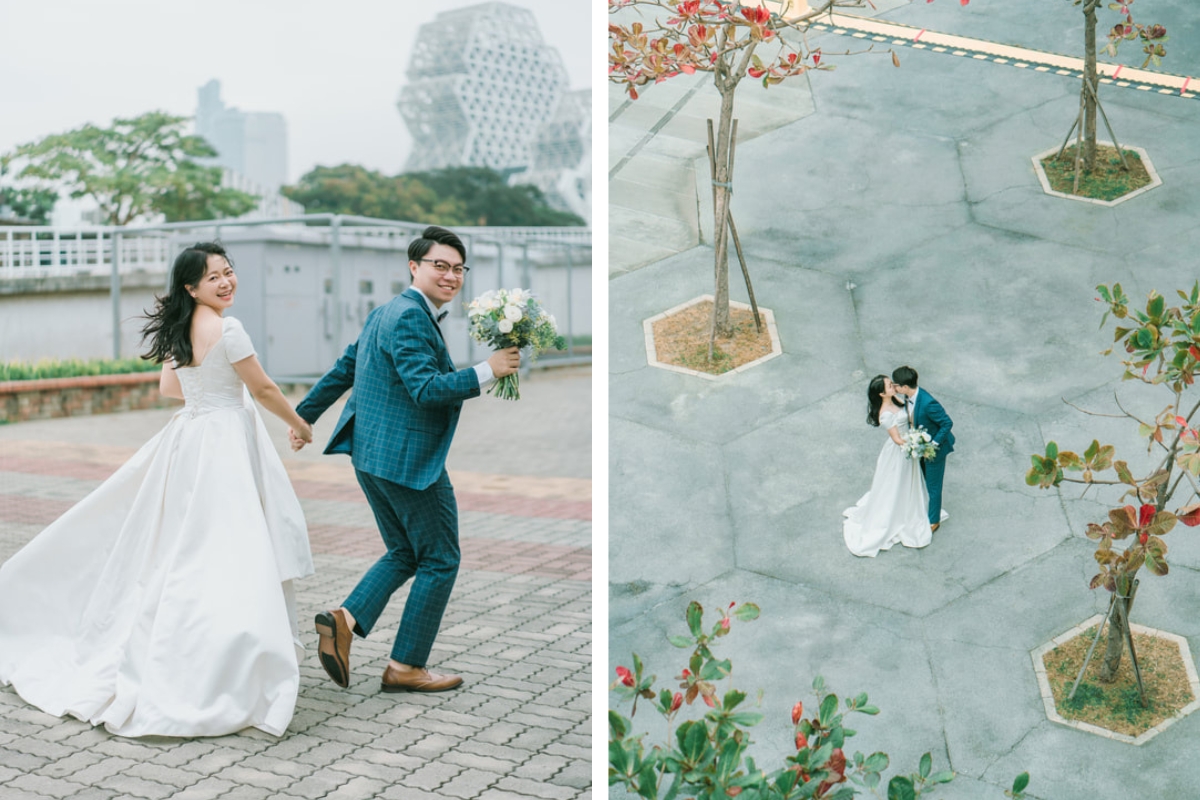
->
xmin=196 ymin=80 xmax=288 ymax=194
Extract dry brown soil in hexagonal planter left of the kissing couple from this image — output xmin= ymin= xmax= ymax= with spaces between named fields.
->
xmin=653 ymin=301 xmax=770 ymax=375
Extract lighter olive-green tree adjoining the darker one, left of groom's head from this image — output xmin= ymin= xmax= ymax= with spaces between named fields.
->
xmin=283 ymin=164 xmax=467 ymax=225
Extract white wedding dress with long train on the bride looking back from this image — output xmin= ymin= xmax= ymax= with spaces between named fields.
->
xmin=0 ymin=318 xmax=312 ymax=736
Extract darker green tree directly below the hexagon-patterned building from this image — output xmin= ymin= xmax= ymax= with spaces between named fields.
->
xmin=408 ymin=167 xmax=587 ymax=227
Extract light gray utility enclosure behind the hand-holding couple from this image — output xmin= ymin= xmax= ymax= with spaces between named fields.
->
xmin=221 ymin=224 xmax=592 ymax=380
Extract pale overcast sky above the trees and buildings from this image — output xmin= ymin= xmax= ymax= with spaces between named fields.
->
xmin=0 ymin=0 xmax=592 ymax=181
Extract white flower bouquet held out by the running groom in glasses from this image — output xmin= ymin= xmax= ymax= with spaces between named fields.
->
xmin=467 ymin=289 xmax=566 ymax=399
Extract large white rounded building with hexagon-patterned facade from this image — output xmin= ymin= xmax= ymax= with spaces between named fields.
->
xmin=396 ymin=2 xmax=568 ymax=173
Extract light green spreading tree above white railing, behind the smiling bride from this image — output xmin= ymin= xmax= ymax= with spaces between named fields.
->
xmin=4 ymin=112 xmax=258 ymax=225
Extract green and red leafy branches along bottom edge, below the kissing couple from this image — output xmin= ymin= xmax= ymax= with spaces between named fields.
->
xmin=608 ymin=601 xmax=964 ymax=800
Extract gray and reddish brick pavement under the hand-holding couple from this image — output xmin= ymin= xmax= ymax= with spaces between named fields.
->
xmin=0 ymin=369 xmax=592 ymax=800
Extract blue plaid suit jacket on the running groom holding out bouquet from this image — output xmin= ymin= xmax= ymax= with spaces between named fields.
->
xmin=296 ymin=288 xmax=480 ymax=489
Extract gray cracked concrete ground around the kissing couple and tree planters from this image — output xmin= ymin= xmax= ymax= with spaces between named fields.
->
xmin=607 ymin=0 xmax=1200 ymax=800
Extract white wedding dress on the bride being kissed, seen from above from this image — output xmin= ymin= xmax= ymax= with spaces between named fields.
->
xmin=841 ymin=409 xmax=949 ymax=558
